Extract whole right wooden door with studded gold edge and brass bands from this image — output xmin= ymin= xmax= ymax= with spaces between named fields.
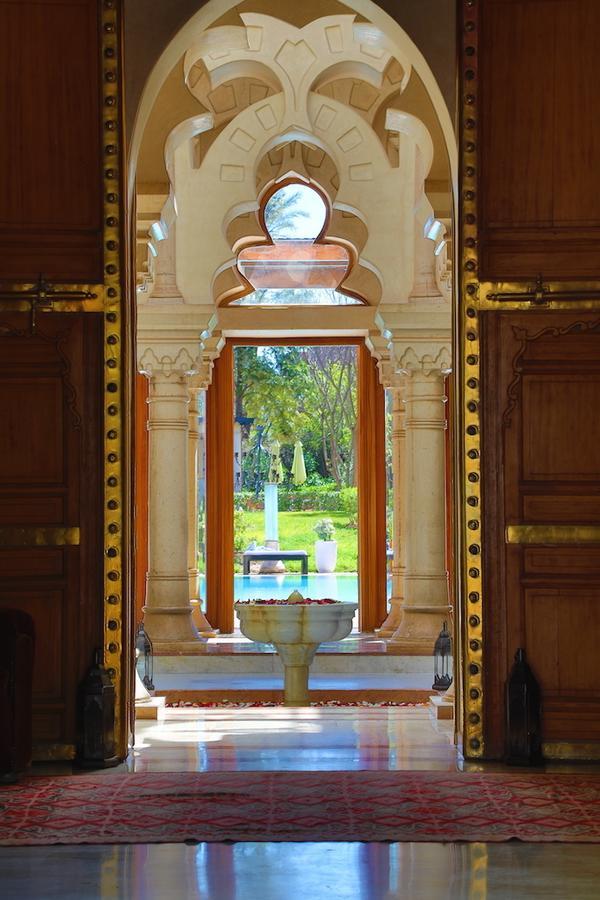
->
xmin=458 ymin=0 xmax=600 ymax=758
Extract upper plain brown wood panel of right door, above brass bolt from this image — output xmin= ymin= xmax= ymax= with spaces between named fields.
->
xmin=478 ymin=0 xmax=600 ymax=281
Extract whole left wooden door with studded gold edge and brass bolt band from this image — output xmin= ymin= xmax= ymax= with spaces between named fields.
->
xmin=0 ymin=0 xmax=133 ymax=758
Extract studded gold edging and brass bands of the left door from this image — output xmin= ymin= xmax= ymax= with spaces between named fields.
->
xmin=0 ymin=0 xmax=126 ymax=759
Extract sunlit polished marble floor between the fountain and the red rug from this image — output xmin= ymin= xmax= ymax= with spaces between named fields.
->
xmin=128 ymin=707 xmax=462 ymax=772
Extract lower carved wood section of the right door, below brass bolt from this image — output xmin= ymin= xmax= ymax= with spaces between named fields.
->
xmin=482 ymin=311 xmax=600 ymax=750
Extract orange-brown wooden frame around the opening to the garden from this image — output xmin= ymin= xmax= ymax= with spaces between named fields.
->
xmin=206 ymin=335 xmax=387 ymax=633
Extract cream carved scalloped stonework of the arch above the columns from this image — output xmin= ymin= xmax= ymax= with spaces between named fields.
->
xmin=137 ymin=2 xmax=451 ymax=376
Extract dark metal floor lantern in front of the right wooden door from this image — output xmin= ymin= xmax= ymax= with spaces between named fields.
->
xmin=506 ymin=647 xmax=543 ymax=766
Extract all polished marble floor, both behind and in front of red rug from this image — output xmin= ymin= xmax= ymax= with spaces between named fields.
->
xmin=0 ymin=707 xmax=600 ymax=900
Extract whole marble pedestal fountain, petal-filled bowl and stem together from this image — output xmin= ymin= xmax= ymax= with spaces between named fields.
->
xmin=235 ymin=602 xmax=357 ymax=706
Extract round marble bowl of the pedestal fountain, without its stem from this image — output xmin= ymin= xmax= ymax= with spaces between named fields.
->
xmin=234 ymin=602 xmax=358 ymax=645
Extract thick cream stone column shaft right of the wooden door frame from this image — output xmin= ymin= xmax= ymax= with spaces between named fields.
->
xmin=390 ymin=365 xmax=448 ymax=655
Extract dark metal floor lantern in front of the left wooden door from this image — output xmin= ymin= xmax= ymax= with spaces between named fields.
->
xmin=76 ymin=649 xmax=120 ymax=769
